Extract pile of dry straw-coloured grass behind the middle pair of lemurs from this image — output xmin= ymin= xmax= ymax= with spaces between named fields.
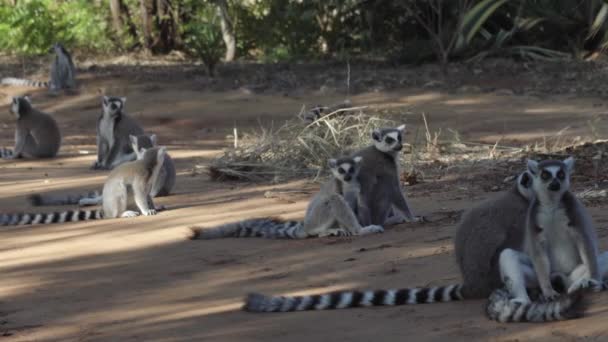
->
xmin=208 ymin=107 xmax=397 ymax=181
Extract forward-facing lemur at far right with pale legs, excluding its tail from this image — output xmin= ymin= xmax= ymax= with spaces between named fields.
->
xmin=500 ymin=157 xmax=608 ymax=303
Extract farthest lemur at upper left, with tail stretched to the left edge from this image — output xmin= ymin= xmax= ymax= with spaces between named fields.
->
xmin=1 ymin=43 xmax=76 ymax=91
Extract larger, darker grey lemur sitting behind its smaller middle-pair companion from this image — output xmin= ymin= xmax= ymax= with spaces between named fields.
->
xmin=354 ymin=125 xmax=420 ymax=226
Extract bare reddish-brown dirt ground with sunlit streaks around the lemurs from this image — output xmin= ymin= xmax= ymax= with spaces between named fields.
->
xmin=0 ymin=56 xmax=608 ymax=341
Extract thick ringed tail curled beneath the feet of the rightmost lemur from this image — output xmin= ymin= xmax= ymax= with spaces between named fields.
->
xmin=486 ymin=289 xmax=586 ymax=323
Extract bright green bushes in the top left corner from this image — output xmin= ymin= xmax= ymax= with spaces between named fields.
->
xmin=0 ymin=0 xmax=111 ymax=55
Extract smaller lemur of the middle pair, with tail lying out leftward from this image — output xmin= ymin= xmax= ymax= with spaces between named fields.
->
xmin=190 ymin=157 xmax=383 ymax=240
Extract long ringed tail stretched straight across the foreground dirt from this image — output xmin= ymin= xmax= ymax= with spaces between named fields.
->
xmin=243 ymin=285 xmax=464 ymax=312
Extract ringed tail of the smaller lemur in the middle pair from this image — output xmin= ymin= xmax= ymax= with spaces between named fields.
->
xmin=190 ymin=218 xmax=307 ymax=240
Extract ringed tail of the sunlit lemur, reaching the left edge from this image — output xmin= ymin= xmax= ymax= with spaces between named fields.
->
xmin=0 ymin=209 xmax=103 ymax=226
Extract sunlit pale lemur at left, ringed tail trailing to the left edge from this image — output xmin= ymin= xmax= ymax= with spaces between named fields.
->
xmin=0 ymin=147 xmax=165 ymax=226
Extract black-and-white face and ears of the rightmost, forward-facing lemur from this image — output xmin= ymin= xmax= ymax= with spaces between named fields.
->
xmin=528 ymin=157 xmax=574 ymax=197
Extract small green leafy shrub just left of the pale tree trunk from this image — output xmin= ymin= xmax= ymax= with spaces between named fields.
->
xmin=184 ymin=7 xmax=225 ymax=76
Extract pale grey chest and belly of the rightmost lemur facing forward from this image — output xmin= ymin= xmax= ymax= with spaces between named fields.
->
xmin=536 ymin=205 xmax=581 ymax=274
